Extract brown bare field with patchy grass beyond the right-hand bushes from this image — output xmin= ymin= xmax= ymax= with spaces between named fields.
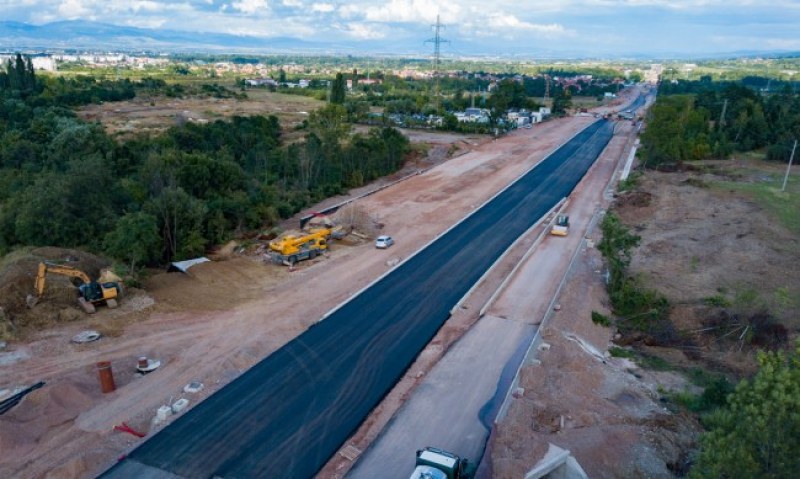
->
xmin=616 ymin=159 xmax=800 ymax=370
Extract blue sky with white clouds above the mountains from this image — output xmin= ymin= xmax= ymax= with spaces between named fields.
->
xmin=0 ymin=0 xmax=800 ymax=56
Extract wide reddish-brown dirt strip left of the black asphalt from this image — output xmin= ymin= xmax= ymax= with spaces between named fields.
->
xmin=0 ymin=89 xmax=636 ymax=477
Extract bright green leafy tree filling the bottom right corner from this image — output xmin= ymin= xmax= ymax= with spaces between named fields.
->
xmin=692 ymin=341 xmax=800 ymax=479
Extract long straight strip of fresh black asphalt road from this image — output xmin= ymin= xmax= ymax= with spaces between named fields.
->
xmin=102 ymin=120 xmax=613 ymax=478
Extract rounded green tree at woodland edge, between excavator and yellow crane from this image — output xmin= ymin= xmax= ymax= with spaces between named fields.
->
xmin=103 ymin=211 xmax=161 ymax=272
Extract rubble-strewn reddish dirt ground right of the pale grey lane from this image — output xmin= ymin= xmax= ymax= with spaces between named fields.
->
xmin=484 ymin=230 xmax=699 ymax=479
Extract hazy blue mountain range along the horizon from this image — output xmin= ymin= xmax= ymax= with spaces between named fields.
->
xmin=0 ymin=20 xmax=800 ymax=60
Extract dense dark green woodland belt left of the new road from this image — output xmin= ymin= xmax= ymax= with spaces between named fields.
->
xmin=0 ymin=55 xmax=408 ymax=268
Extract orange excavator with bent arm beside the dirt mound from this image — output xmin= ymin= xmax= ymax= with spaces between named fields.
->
xmin=27 ymin=262 xmax=122 ymax=314
